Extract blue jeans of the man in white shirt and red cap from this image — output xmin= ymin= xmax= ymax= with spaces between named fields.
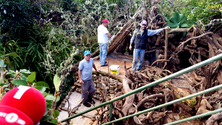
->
xmin=99 ymin=43 xmax=108 ymax=66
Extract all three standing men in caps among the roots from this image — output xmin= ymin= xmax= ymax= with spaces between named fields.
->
xmin=78 ymin=19 xmax=170 ymax=107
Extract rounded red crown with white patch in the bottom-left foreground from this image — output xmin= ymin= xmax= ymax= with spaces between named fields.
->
xmin=0 ymin=86 xmax=46 ymax=125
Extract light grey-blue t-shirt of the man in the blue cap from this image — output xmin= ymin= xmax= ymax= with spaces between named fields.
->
xmin=79 ymin=58 xmax=94 ymax=80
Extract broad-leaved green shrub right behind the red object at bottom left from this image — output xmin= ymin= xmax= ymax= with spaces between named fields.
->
xmin=3 ymin=70 xmax=61 ymax=124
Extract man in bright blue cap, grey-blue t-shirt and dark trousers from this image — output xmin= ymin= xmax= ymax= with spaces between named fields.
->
xmin=78 ymin=50 xmax=98 ymax=107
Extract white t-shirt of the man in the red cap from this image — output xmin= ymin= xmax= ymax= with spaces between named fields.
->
xmin=97 ymin=24 xmax=109 ymax=43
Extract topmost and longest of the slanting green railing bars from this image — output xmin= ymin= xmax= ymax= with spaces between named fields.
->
xmin=60 ymin=54 xmax=222 ymax=122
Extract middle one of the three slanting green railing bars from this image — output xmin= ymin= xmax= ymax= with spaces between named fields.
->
xmin=103 ymin=84 xmax=222 ymax=125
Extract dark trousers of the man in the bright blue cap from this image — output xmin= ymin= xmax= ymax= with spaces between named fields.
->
xmin=81 ymin=79 xmax=96 ymax=103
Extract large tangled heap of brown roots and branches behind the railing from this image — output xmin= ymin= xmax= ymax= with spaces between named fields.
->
xmin=57 ymin=1 xmax=222 ymax=125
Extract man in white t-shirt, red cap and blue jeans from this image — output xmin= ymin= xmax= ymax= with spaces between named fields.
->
xmin=97 ymin=19 xmax=111 ymax=66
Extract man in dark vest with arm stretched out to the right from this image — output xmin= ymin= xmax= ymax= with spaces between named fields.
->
xmin=129 ymin=20 xmax=170 ymax=72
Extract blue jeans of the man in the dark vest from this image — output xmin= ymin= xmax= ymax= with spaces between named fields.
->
xmin=132 ymin=49 xmax=145 ymax=72
